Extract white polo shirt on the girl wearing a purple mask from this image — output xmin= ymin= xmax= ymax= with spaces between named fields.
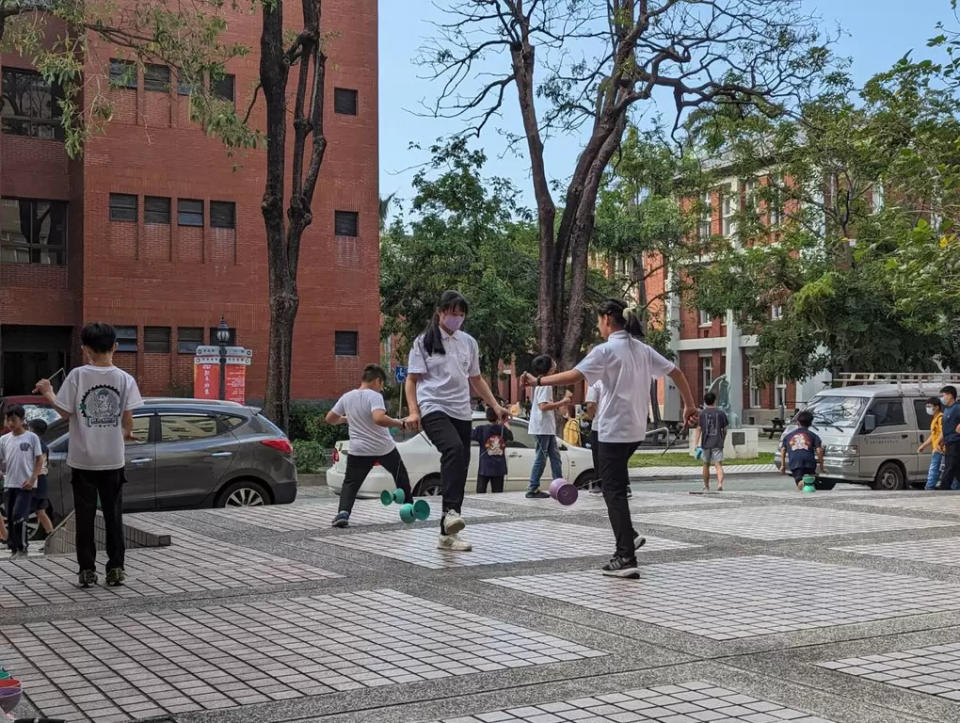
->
xmin=407 ymin=327 xmax=480 ymax=421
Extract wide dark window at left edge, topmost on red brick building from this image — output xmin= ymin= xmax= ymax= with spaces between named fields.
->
xmin=0 ymin=68 xmax=63 ymax=140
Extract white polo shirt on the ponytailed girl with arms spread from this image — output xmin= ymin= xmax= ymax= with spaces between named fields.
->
xmin=576 ymin=330 xmax=676 ymax=442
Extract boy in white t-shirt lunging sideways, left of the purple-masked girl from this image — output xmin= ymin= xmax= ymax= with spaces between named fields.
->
xmin=327 ymin=364 xmax=413 ymax=527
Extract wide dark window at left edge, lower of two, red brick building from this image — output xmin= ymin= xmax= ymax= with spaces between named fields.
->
xmin=0 ymin=198 xmax=67 ymax=266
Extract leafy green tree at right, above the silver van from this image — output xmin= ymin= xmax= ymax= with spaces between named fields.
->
xmin=695 ymin=58 xmax=960 ymax=382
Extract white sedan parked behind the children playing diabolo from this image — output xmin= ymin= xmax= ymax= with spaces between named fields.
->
xmin=327 ymin=414 xmax=596 ymax=497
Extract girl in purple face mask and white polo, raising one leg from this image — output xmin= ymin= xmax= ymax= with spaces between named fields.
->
xmin=406 ymin=291 xmax=510 ymax=552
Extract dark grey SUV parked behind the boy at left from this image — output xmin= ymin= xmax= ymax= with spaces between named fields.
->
xmin=34 ymin=399 xmax=297 ymax=516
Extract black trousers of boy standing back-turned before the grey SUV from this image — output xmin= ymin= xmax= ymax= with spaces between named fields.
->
xmin=71 ymin=468 xmax=126 ymax=571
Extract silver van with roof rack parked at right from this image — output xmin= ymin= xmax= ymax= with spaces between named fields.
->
xmin=781 ymin=382 xmax=956 ymax=490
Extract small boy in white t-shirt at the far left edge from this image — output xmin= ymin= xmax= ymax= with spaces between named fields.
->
xmin=0 ymin=404 xmax=43 ymax=557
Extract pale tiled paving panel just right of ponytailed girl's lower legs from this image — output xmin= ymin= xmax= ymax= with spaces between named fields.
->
xmin=634 ymin=505 xmax=957 ymax=540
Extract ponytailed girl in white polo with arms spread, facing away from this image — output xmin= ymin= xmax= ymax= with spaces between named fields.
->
xmin=533 ymin=299 xmax=697 ymax=579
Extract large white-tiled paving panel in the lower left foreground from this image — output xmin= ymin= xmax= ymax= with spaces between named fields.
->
xmin=0 ymin=589 xmax=606 ymax=723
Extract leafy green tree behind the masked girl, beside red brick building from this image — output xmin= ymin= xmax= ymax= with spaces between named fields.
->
xmin=380 ymin=139 xmax=537 ymax=380
